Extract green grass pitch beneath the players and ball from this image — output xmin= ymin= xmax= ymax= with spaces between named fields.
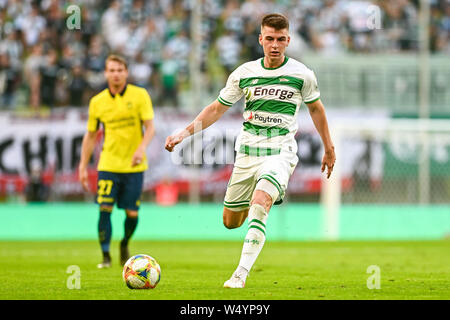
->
xmin=0 ymin=240 xmax=450 ymax=300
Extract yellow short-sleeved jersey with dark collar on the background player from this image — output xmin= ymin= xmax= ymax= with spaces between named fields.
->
xmin=87 ymin=84 xmax=153 ymax=173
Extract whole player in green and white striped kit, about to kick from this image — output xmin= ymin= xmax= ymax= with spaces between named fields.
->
xmin=165 ymin=14 xmax=336 ymax=288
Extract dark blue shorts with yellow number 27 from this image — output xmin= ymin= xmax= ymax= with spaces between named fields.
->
xmin=96 ymin=171 xmax=144 ymax=210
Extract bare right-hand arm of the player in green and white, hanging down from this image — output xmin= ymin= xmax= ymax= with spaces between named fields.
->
xmin=306 ymin=99 xmax=336 ymax=178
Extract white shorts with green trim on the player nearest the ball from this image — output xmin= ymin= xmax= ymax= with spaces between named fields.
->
xmin=223 ymin=152 xmax=298 ymax=210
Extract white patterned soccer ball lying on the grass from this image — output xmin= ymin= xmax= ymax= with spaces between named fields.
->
xmin=122 ymin=254 xmax=161 ymax=289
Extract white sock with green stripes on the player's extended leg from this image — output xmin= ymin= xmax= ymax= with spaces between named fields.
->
xmin=236 ymin=204 xmax=268 ymax=276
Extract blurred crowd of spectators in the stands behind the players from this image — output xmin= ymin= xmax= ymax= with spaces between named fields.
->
xmin=0 ymin=0 xmax=450 ymax=110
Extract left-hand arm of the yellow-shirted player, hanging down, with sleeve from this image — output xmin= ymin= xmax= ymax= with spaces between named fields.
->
xmin=78 ymin=99 xmax=99 ymax=191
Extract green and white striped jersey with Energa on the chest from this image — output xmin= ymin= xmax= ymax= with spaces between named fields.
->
xmin=218 ymin=57 xmax=320 ymax=156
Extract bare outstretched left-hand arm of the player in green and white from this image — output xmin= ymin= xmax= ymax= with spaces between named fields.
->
xmin=165 ymin=100 xmax=230 ymax=152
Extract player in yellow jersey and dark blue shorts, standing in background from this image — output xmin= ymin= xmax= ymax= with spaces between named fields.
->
xmin=79 ymin=55 xmax=155 ymax=268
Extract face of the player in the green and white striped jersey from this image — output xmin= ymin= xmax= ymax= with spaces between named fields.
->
xmin=259 ymin=26 xmax=291 ymax=60
